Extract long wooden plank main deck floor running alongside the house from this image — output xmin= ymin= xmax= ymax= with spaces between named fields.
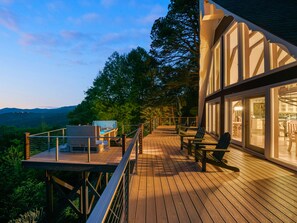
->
xmin=129 ymin=127 xmax=297 ymax=223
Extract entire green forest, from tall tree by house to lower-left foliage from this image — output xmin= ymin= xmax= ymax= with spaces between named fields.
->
xmin=0 ymin=0 xmax=199 ymax=222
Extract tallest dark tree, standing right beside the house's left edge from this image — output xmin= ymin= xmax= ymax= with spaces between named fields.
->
xmin=150 ymin=0 xmax=199 ymax=115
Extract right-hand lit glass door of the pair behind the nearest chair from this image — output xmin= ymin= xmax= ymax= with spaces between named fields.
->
xmin=246 ymin=97 xmax=265 ymax=154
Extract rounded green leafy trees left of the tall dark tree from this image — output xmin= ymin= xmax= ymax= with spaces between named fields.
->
xmin=69 ymin=47 xmax=155 ymax=126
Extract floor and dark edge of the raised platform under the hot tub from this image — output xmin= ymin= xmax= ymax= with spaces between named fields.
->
xmin=22 ymin=147 xmax=122 ymax=172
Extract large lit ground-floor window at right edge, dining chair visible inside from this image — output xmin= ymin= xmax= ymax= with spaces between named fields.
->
xmin=271 ymin=83 xmax=297 ymax=165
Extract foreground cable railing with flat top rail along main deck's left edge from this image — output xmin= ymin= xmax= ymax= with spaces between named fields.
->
xmin=87 ymin=125 xmax=143 ymax=223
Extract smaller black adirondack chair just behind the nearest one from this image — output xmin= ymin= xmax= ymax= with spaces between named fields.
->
xmin=179 ymin=126 xmax=205 ymax=151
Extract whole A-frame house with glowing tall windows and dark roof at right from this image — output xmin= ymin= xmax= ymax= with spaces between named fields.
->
xmin=199 ymin=0 xmax=297 ymax=170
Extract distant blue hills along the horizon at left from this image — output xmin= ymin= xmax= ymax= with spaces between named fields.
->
xmin=0 ymin=106 xmax=76 ymax=128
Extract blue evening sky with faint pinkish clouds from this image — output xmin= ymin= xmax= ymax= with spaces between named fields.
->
xmin=0 ymin=0 xmax=170 ymax=108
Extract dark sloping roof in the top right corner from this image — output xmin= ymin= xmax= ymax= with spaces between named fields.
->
xmin=213 ymin=0 xmax=297 ymax=46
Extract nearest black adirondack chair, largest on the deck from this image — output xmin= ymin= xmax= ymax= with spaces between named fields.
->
xmin=194 ymin=132 xmax=239 ymax=172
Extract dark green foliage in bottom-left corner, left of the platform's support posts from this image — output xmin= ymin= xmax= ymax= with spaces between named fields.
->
xmin=0 ymin=134 xmax=45 ymax=222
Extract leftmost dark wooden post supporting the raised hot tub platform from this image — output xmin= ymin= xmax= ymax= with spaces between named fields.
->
xmin=45 ymin=170 xmax=54 ymax=223
